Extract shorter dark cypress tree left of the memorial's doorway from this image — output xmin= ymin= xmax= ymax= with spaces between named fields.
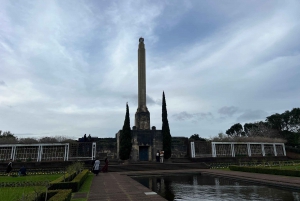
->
xmin=119 ymin=103 xmax=132 ymax=160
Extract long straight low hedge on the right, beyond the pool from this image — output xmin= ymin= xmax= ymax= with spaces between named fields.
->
xmin=229 ymin=165 xmax=300 ymax=177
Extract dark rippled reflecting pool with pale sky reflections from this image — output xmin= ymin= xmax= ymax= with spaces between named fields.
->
xmin=132 ymin=174 xmax=300 ymax=201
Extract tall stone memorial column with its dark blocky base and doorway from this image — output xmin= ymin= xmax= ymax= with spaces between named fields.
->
xmin=116 ymin=38 xmax=162 ymax=161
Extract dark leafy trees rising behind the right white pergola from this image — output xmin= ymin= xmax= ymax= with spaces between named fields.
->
xmin=226 ymin=108 xmax=300 ymax=146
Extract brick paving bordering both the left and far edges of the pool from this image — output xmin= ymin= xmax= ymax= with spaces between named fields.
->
xmin=88 ymin=169 xmax=300 ymax=201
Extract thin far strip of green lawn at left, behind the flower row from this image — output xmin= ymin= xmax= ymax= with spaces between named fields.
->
xmin=0 ymin=174 xmax=63 ymax=182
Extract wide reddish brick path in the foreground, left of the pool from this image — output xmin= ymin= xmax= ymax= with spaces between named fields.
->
xmin=88 ymin=172 xmax=166 ymax=201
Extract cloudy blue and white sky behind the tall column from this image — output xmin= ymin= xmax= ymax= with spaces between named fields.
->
xmin=0 ymin=0 xmax=300 ymax=139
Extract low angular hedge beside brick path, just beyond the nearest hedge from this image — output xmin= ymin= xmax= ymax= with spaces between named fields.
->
xmin=49 ymin=170 xmax=89 ymax=192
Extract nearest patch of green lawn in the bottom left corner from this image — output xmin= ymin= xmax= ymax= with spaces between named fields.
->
xmin=0 ymin=186 xmax=46 ymax=201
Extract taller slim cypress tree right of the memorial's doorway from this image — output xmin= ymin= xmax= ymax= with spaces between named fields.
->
xmin=161 ymin=92 xmax=172 ymax=159
